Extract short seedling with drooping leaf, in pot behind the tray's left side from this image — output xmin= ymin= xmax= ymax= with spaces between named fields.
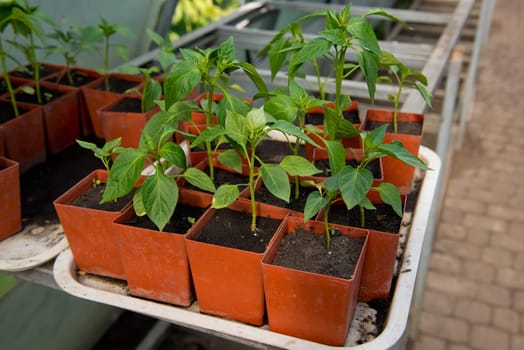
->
xmin=118 ymin=65 xmax=162 ymax=113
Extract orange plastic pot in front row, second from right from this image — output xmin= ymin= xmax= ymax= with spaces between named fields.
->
xmin=186 ymin=199 xmax=289 ymax=326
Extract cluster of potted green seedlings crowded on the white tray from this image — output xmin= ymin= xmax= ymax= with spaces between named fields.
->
xmin=0 ymin=0 xmax=430 ymax=345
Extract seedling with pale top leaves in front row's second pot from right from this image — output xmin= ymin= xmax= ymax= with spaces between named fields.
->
xmin=201 ymin=106 xmax=320 ymax=233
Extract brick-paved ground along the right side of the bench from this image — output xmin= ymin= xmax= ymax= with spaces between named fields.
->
xmin=410 ymin=0 xmax=524 ymax=350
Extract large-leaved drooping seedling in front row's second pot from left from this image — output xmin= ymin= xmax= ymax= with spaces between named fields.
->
xmin=102 ymin=101 xmax=215 ymax=230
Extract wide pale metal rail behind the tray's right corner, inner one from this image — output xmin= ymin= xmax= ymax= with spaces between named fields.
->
xmin=401 ymin=0 xmax=475 ymax=113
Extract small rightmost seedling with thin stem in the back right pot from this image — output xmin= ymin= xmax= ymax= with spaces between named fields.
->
xmin=378 ymin=51 xmax=432 ymax=134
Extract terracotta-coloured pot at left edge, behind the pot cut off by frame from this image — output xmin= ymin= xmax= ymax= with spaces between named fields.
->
xmin=0 ymin=96 xmax=47 ymax=174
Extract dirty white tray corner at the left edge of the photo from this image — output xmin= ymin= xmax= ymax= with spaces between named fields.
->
xmin=0 ymin=224 xmax=68 ymax=272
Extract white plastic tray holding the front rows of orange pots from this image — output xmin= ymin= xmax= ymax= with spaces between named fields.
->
xmin=53 ymin=147 xmax=440 ymax=350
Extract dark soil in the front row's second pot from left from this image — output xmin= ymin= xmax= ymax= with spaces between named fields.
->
xmin=125 ymin=203 xmax=207 ymax=234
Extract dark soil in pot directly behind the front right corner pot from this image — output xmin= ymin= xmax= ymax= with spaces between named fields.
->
xmin=329 ymin=204 xmax=402 ymax=233
